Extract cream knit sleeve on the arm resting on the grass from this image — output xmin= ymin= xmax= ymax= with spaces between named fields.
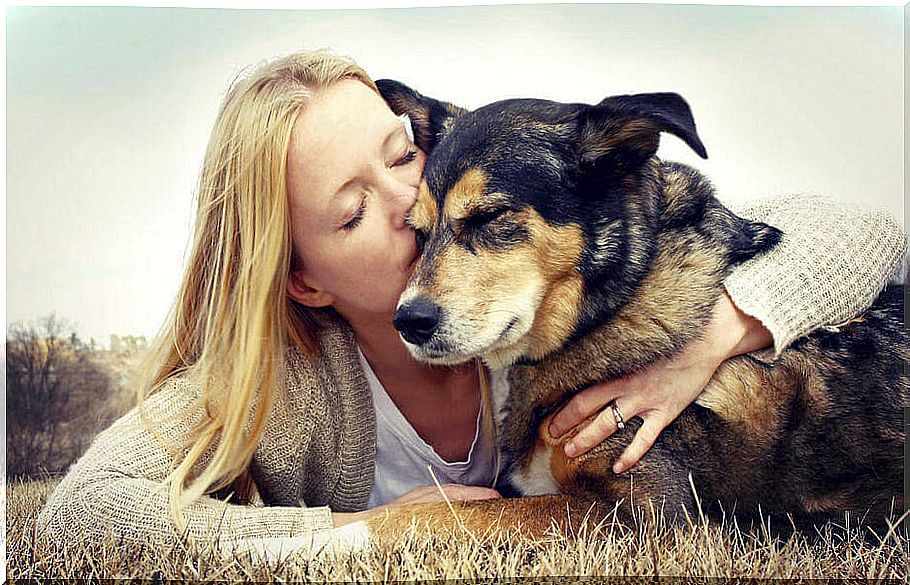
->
xmin=37 ymin=379 xmax=333 ymax=547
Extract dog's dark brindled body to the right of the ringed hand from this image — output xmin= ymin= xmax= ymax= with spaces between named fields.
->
xmin=663 ymin=286 xmax=910 ymax=522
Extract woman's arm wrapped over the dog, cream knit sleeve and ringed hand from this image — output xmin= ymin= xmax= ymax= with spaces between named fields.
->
xmin=549 ymin=196 xmax=906 ymax=473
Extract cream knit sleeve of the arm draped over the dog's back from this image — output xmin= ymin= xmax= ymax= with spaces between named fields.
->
xmin=724 ymin=195 xmax=906 ymax=359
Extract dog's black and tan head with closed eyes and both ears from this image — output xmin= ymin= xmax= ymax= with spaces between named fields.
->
xmin=377 ymin=80 xmax=706 ymax=365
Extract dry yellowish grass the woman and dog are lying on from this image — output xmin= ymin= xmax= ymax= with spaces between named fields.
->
xmin=7 ymin=481 xmax=910 ymax=583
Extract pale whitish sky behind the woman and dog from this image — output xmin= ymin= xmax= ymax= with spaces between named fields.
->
xmin=6 ymin=5 xmax=904 ymax=342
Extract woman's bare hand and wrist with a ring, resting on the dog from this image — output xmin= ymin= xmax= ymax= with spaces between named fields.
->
xmin=549 ymin=291 xmax=772 ymax=473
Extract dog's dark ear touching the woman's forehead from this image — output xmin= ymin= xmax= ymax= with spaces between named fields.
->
xmin=376 ymin=79 xmax=467 ymax=154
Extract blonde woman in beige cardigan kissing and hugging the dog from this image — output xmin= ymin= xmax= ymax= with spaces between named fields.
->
xmin=39 ymin=53 xmax=903 ymax=543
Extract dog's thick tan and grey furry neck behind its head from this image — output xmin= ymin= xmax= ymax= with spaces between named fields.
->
xmin=519 ymin=163 xmax=730 ymax=407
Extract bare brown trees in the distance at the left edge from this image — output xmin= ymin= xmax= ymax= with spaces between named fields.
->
xmin=6 ymin=315 xmax=140 ymax=477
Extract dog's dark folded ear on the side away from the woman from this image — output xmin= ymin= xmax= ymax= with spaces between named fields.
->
xmin=579 ymin=93 xmax=708 ymax=176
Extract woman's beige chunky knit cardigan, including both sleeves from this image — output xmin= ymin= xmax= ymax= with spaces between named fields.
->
xmin=37 ymin=196 xmax=905 ymax=546
